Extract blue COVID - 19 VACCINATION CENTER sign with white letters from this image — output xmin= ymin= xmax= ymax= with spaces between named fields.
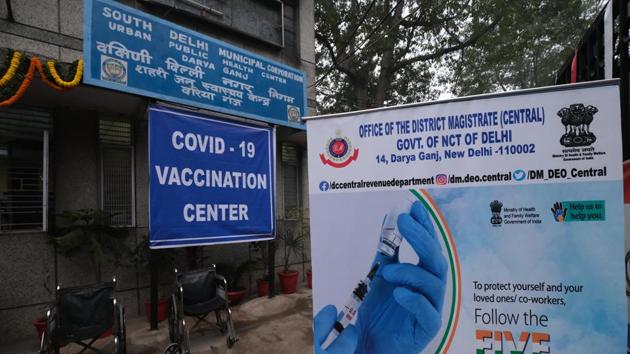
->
xmin=149 ymin=106 xmax=275 ymax=248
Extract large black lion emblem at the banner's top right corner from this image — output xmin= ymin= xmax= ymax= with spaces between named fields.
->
xmin=558 ymin=103 xmax=599 ymax=147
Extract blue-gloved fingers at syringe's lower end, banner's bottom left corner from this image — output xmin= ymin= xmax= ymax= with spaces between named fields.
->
xmin=313 ymin=305 xmax=357 ymax=354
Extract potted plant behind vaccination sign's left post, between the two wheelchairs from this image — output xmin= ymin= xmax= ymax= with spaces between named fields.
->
xmin=128 ymin=234 xmax=174 ymax=322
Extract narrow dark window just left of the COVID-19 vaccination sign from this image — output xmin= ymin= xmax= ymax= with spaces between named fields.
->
xmin=98 ymin=119 xmax=135 ymax=226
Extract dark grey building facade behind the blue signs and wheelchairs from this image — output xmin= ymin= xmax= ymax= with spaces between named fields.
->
xmin=0 ymin=0 xmax=315 ymax=343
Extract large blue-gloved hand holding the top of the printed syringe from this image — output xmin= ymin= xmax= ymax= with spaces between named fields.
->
xmin=355 ymin=202 xmax=448 ymax=354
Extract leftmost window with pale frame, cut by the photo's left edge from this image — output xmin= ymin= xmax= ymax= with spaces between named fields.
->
xmin=0 ymin=108 xmax=52 ymax=232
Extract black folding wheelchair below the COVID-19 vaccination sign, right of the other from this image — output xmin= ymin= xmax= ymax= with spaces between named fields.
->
xmin=164 ymin=265 xmax=238 ymax=354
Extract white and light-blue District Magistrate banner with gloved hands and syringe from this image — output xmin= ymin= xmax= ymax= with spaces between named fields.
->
xmin=307 ymin=81 xmax=626 ymax=354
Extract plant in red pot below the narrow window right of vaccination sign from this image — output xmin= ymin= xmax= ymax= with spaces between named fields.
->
xmin=277 ymin=223 xmax=304 ymax=294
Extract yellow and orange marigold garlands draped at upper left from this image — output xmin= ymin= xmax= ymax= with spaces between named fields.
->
xmin=0 ymin=49 xmax=83 ymax=107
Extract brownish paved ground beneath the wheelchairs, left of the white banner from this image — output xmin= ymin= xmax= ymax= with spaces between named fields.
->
xmin=0 ymin=289 xmax=313 ymax=354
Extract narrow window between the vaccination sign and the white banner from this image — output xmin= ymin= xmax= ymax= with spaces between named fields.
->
xmin=281 ymin=143 xmax=300 ymax=218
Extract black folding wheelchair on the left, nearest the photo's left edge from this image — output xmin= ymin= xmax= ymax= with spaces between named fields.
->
xmin=39 ymin=278 xmax=126 ymax=354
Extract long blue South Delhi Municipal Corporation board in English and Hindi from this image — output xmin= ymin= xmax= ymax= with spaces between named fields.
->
xmin=83 ymin=0 xmax=306 ymax=129
